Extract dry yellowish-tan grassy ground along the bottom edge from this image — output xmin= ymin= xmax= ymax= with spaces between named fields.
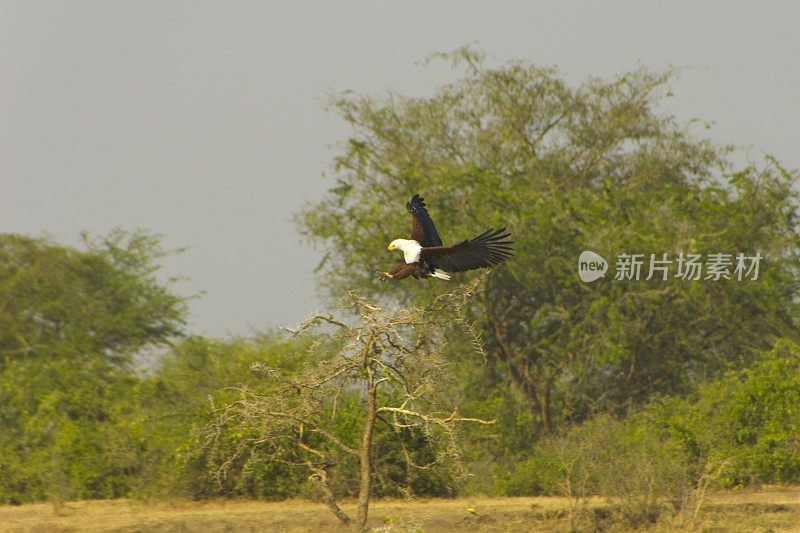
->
xmin=0 ymin=487 xmax=800 ymax=533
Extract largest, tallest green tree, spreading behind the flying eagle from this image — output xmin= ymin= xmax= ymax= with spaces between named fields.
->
xmin=297 ymin=48 xmax=800 ymax=433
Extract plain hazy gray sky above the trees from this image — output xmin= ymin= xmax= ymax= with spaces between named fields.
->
xmin=0 ymin=0 xmax=800 ymax=336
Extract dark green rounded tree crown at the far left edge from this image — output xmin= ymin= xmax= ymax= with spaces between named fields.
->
xmin=0 ymin=230 xmax=186 ymax=368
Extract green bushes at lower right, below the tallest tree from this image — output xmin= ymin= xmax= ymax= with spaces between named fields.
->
xmin=496 ymin=339 xmax=800 ymax=527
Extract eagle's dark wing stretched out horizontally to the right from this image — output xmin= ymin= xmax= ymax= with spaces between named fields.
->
xmin=420 ymin=228 xmax=514 ymax=272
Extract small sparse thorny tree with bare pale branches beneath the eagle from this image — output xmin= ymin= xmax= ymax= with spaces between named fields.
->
xmin=206 ymin=285 xmax=492 ymax=531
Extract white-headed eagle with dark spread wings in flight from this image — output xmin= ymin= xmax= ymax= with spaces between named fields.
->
xmin=375 ymin=194 xmax=514 ymax=281
